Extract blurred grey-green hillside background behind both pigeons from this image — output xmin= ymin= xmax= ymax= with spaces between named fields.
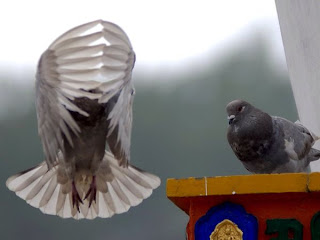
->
xmin=0 ymin=32 xmax=297 ymax=240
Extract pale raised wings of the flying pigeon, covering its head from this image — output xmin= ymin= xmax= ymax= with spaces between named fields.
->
xmin=36 ymin=20 xmax=135 ymax=166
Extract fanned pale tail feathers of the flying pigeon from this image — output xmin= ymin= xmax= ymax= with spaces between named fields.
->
xmin=6 ymin=152 xmax=160 ymax=219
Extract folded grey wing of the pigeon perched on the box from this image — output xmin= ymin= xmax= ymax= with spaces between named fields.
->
xmin=274 ymin=117 xmax=318 ymax=160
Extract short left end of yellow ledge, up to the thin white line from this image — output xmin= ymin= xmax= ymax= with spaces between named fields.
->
xmin=167 ymin=178 xmax=206 ymax=197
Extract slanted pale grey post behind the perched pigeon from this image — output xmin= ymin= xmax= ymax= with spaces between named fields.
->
xmin=275 ymin=0 xmax=320 ymax=171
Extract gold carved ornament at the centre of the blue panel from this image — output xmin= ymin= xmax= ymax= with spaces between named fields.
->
xmin=210 ymin=219 xmax=243 ymax=240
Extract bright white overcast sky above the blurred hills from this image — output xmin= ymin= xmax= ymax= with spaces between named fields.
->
xmin=0 ymin=0 xmax=281 ymax=72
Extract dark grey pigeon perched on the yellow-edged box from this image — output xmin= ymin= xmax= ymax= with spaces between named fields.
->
xmin=226 ymin=100 xmax=320 ymax=173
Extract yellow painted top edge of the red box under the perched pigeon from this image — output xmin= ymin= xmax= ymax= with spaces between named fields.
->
xmin=167 ymin=173 xmax=320 ymax=197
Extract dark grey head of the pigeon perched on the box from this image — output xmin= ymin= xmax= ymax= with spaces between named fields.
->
xmin=226 ymin=100 xmax=252 ymax=125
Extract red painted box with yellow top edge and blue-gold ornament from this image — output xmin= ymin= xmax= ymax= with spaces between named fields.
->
xmin=167 ymin=173 xmax=320 ymax=240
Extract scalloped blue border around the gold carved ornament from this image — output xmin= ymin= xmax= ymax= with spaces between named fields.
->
xmin=195 ymin=202 xmax=258 ymax=240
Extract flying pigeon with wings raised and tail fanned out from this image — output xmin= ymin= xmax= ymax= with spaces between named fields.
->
xmin=6 ymin=20 xmax=160 ymax=219
